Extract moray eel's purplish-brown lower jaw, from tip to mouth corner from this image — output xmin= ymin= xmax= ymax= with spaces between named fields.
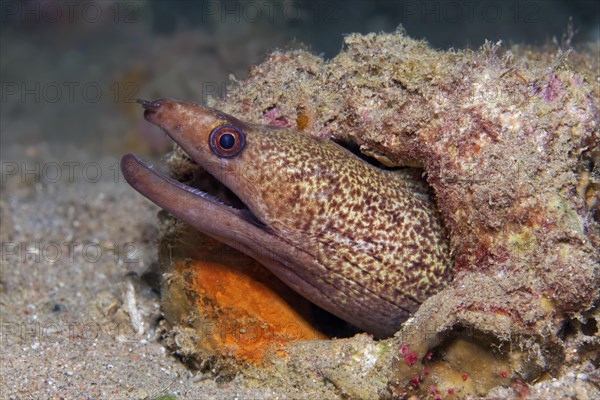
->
xmin=121 ymin=153 xmax=266 ymax=237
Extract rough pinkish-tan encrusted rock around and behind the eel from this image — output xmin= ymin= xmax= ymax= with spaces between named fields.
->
xmin=158 ymin=32 xmax=600 ymax=399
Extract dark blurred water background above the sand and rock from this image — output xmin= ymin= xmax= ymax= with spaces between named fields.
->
xmin=0 ymin=0 xmax=600 ymax=154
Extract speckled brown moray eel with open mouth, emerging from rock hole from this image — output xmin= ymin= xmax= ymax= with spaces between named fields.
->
xmin=121 ymin=99 xmax=451 ymax=338
